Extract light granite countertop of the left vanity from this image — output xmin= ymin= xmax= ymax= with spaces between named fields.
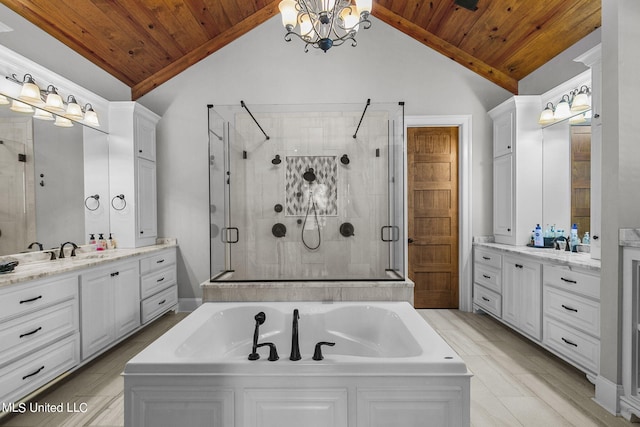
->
xmin=0 ymin=239 xmax=177 ymax=288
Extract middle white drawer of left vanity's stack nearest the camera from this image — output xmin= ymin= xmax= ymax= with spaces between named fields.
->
xmin=0 ymin=299 xmax=78 ymax=366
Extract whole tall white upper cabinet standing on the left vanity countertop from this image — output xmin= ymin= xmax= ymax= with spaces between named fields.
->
xmin=109 ymin=102 xmax=160 ymax=248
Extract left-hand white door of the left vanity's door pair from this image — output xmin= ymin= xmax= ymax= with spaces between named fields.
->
xmin=80 ymin=269 xmax=115 ymax=360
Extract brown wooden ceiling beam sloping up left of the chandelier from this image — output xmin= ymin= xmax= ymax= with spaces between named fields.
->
xmin=131 ymin=0 xmax=280 ymax=101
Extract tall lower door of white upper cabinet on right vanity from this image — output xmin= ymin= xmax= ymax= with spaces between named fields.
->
xmin=493 ymin=154 xmax=513 ymax=241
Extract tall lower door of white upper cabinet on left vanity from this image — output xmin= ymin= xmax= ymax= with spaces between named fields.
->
xmin=136 ymin=158 xmax=158 ymax=243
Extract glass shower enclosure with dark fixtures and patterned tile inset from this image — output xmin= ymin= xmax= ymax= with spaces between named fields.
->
xmin=208 ymin=101 xmax=406 ymax=282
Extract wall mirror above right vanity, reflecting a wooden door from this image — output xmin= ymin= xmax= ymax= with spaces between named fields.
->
xmin=540 ymin=111 xmax=591 ymax=239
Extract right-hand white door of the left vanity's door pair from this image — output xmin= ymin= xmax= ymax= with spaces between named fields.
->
xmin=113 ymin=261 xmax=140 ymax=339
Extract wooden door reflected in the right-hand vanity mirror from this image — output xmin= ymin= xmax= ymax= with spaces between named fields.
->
xmin=571 ymin=126 xmax=591 ymax=238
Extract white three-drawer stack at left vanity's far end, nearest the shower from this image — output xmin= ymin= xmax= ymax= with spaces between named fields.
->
xmin=140 ymin=248 xmax=178 ymax=324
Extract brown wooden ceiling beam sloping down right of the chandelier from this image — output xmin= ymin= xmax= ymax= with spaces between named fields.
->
xmin=372 ymin=3 xmax=518 ymax=95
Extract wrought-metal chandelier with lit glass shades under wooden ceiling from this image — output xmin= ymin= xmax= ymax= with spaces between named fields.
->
xmin=278 ymin=0 xmax=372 ymax=52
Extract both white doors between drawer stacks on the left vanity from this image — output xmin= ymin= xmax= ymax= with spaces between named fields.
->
xmin=80 ymin=260 xmax=140 ymax=360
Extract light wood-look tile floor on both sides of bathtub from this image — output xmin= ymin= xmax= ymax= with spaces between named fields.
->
xmin=0 ymin=310 xmax=637 ymax=427
